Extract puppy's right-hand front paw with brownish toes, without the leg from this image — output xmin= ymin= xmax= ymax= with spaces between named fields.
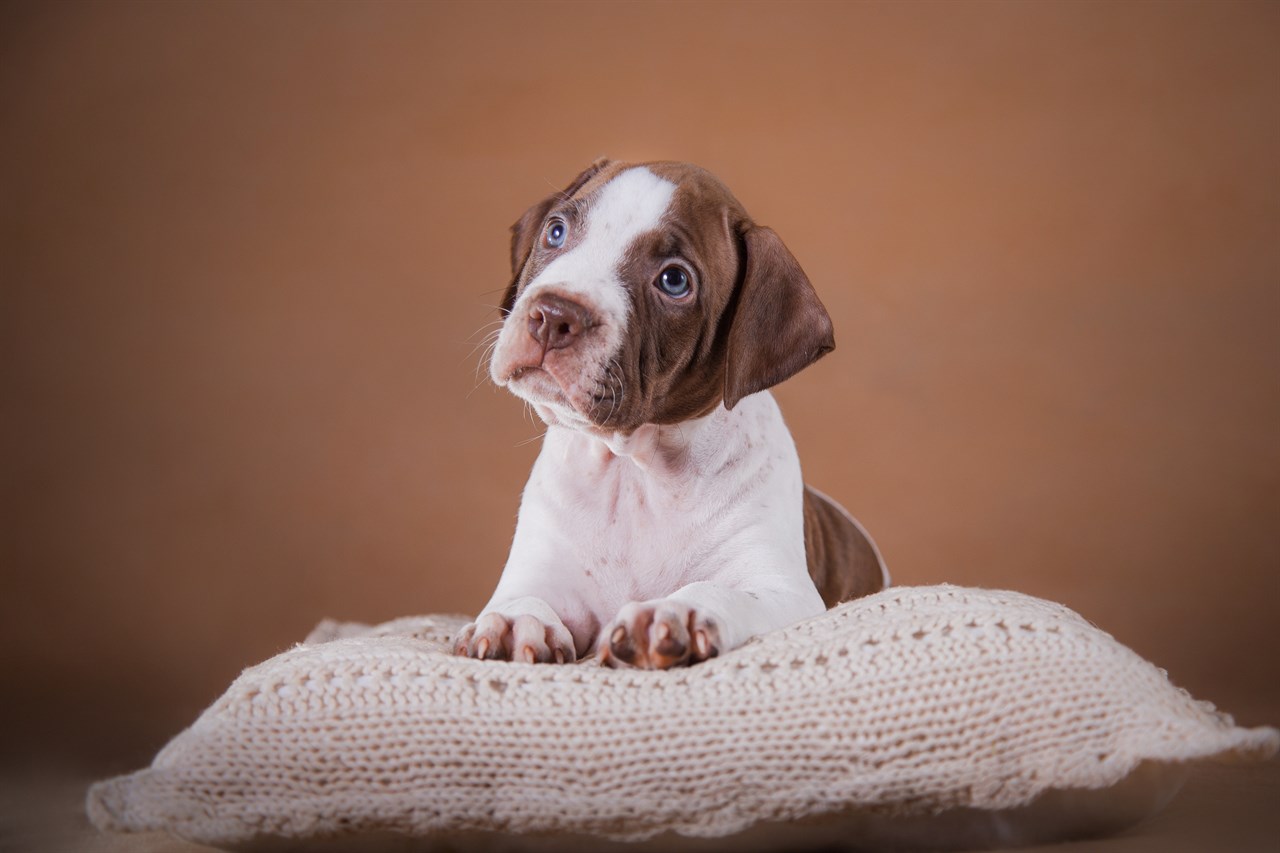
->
xmin=598 ymin=599 xmax=721 ymax=670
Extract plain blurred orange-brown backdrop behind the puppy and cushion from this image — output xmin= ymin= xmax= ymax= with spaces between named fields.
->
xmin=0 ymin=3 xmax=1280 ymax=799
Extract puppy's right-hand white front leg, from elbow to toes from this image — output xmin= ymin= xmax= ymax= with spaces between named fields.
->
xmin=598 ymin=579 xmax=824 ymax=670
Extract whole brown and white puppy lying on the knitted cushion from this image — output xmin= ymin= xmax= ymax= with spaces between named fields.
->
xmin=456 ymin=160 xmax=888 ymax=669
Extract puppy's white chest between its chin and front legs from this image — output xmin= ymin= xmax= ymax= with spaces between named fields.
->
xmin=507 ymin=394 xmax=804 ymax=620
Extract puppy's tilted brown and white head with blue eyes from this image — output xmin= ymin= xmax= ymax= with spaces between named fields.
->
xmin=489 ymin=160 xmax=835 ymax=432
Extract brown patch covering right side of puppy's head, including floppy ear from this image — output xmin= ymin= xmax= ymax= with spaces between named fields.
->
xmin=586 ymin=163 xmax=835 ymax=430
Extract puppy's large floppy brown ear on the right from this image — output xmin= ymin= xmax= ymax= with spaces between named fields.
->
xmin=724 ymin=227 xmax=836 ymax=409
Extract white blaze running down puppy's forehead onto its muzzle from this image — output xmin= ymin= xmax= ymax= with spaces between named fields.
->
xmin=490 ymin=167 xmax=676 ymax=422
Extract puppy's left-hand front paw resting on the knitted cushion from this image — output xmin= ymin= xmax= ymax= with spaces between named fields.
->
xmin=453 ymin=596 xmax=577 ymax=663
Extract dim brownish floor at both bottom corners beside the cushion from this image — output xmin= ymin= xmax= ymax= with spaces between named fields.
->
xmin=0 ymin=761 xmax=1280 ymax=853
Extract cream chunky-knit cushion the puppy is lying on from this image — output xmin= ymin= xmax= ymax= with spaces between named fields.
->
xmin=88 ymin=587 xmax=1280 ymax=850
